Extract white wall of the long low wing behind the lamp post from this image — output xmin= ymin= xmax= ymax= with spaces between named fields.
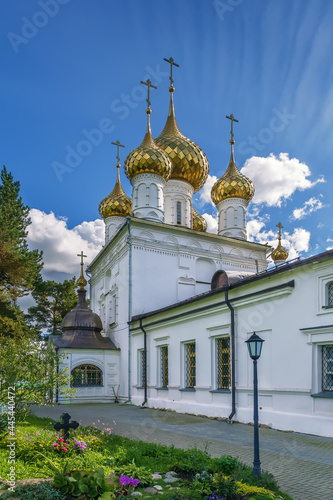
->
xmin=132 ymin=259 xmax=333 ymax=437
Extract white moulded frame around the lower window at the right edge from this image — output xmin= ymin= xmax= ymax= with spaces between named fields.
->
xmin=301 ymin=325 xmax=333 ymax=398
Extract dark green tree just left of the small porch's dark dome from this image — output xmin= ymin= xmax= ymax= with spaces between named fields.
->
xmin=26 ymin=277 xmax=77 ymax=335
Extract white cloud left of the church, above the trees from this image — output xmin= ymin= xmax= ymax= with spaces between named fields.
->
xmin=27 ymin=208 xmax=104 ymax=280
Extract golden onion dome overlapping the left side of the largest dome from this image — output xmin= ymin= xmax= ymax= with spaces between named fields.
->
xmin=125 ymin=112 xmax=171 ymax=181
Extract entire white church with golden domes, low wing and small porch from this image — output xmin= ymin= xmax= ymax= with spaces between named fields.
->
xmin=57 ymin=59 xmax=333 ymax=437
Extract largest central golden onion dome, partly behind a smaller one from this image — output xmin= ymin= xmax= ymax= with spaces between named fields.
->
xmin=155 ymin=85 xmax=209 ymax=192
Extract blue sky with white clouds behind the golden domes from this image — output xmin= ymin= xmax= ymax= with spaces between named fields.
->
xmin=0 ymin=0 xmax=333 ymax=278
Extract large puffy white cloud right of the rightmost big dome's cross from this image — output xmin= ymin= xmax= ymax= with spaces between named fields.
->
xmin=241 ymin=153 xmax=325 ymax=207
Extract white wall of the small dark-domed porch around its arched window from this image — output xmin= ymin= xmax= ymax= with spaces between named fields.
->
xmin=58 ymin=349 xmax=120 ymax=404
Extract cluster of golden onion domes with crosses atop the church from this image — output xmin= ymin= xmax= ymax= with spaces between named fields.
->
xmin=99 ymin=58 xmax=254 ymax=231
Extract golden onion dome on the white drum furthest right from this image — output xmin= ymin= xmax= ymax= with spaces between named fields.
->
xmin=211 ymin=139 xmax=254 ymax=205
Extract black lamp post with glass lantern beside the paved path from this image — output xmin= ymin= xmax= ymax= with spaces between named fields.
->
xmin=246 ymin=332 xmax=264 ymax=477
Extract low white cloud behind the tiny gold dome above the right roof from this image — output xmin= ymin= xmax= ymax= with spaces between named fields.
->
xmin=247 ymin=219 xmax=311 ymax=260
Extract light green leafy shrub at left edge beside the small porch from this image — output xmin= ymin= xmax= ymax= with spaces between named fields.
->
xmin=0 ymin=335 xmax=76 ymax=419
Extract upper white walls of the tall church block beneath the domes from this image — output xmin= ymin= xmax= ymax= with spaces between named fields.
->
xmin=90 ymin=219 xmax=267 ymax=400
